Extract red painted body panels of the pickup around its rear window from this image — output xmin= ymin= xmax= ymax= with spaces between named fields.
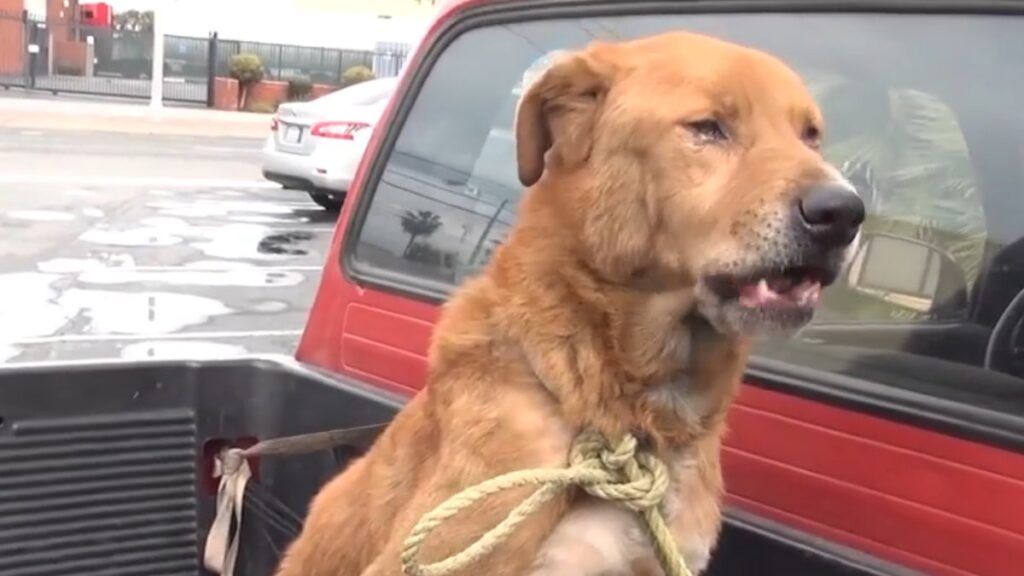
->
xmin=297 ymin=0 xmax=1024 ymax=576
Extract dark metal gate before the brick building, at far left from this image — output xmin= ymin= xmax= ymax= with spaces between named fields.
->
xmin=0 ymin=12 xmax=209 ymax=105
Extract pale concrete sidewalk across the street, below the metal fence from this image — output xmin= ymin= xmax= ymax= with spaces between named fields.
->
xmin=0 ymin=96 xmax=271 ymax=138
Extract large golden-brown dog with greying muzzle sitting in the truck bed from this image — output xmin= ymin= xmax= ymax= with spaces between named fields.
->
xmin=279 ymin=33 xmax=864 ymax=576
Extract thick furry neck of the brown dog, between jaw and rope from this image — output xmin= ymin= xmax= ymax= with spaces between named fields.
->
xmin=487 ymin=227 xmax=746 ymax=448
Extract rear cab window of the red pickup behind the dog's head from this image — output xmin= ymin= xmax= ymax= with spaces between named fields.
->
xmin=348 ymin=13 xmax=1024 ymax=415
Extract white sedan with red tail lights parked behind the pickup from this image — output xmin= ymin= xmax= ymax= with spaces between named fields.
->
xmin=262 ymin=78 xmax=398 ymax=210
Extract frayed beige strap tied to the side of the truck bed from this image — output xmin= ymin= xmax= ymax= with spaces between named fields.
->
xmin=203 ymin=424 xmax=387 ymax=576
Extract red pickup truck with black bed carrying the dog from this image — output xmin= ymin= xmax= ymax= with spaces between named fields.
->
xmin=0 ymin=0 xmax=1024 ymax=576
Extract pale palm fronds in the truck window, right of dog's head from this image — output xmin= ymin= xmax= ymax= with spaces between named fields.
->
xmin=812 ymin=78 xmax=986 ymax=317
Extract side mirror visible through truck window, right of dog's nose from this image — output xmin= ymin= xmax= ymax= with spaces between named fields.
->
xmin=847 ymin=233 xmax=967 ymax=318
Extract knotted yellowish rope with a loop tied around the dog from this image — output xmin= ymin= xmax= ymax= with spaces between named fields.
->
xmin=401 ymin=430 xmax=691 ymax=576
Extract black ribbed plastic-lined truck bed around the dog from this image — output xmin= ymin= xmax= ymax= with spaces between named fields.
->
xmin=0 ymin=357 xmax=902 ymax=576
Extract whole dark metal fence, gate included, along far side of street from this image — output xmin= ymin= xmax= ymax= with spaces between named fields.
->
xmin=0 ymin=12 xmax=409 ymax=106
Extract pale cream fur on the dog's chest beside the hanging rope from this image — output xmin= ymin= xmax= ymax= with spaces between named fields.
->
xmin=529 ymin=450 xmax=721 ymax=576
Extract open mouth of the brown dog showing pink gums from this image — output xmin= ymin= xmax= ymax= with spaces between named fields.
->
xmin=708 ymin=264 xmax=836 ymax=310
